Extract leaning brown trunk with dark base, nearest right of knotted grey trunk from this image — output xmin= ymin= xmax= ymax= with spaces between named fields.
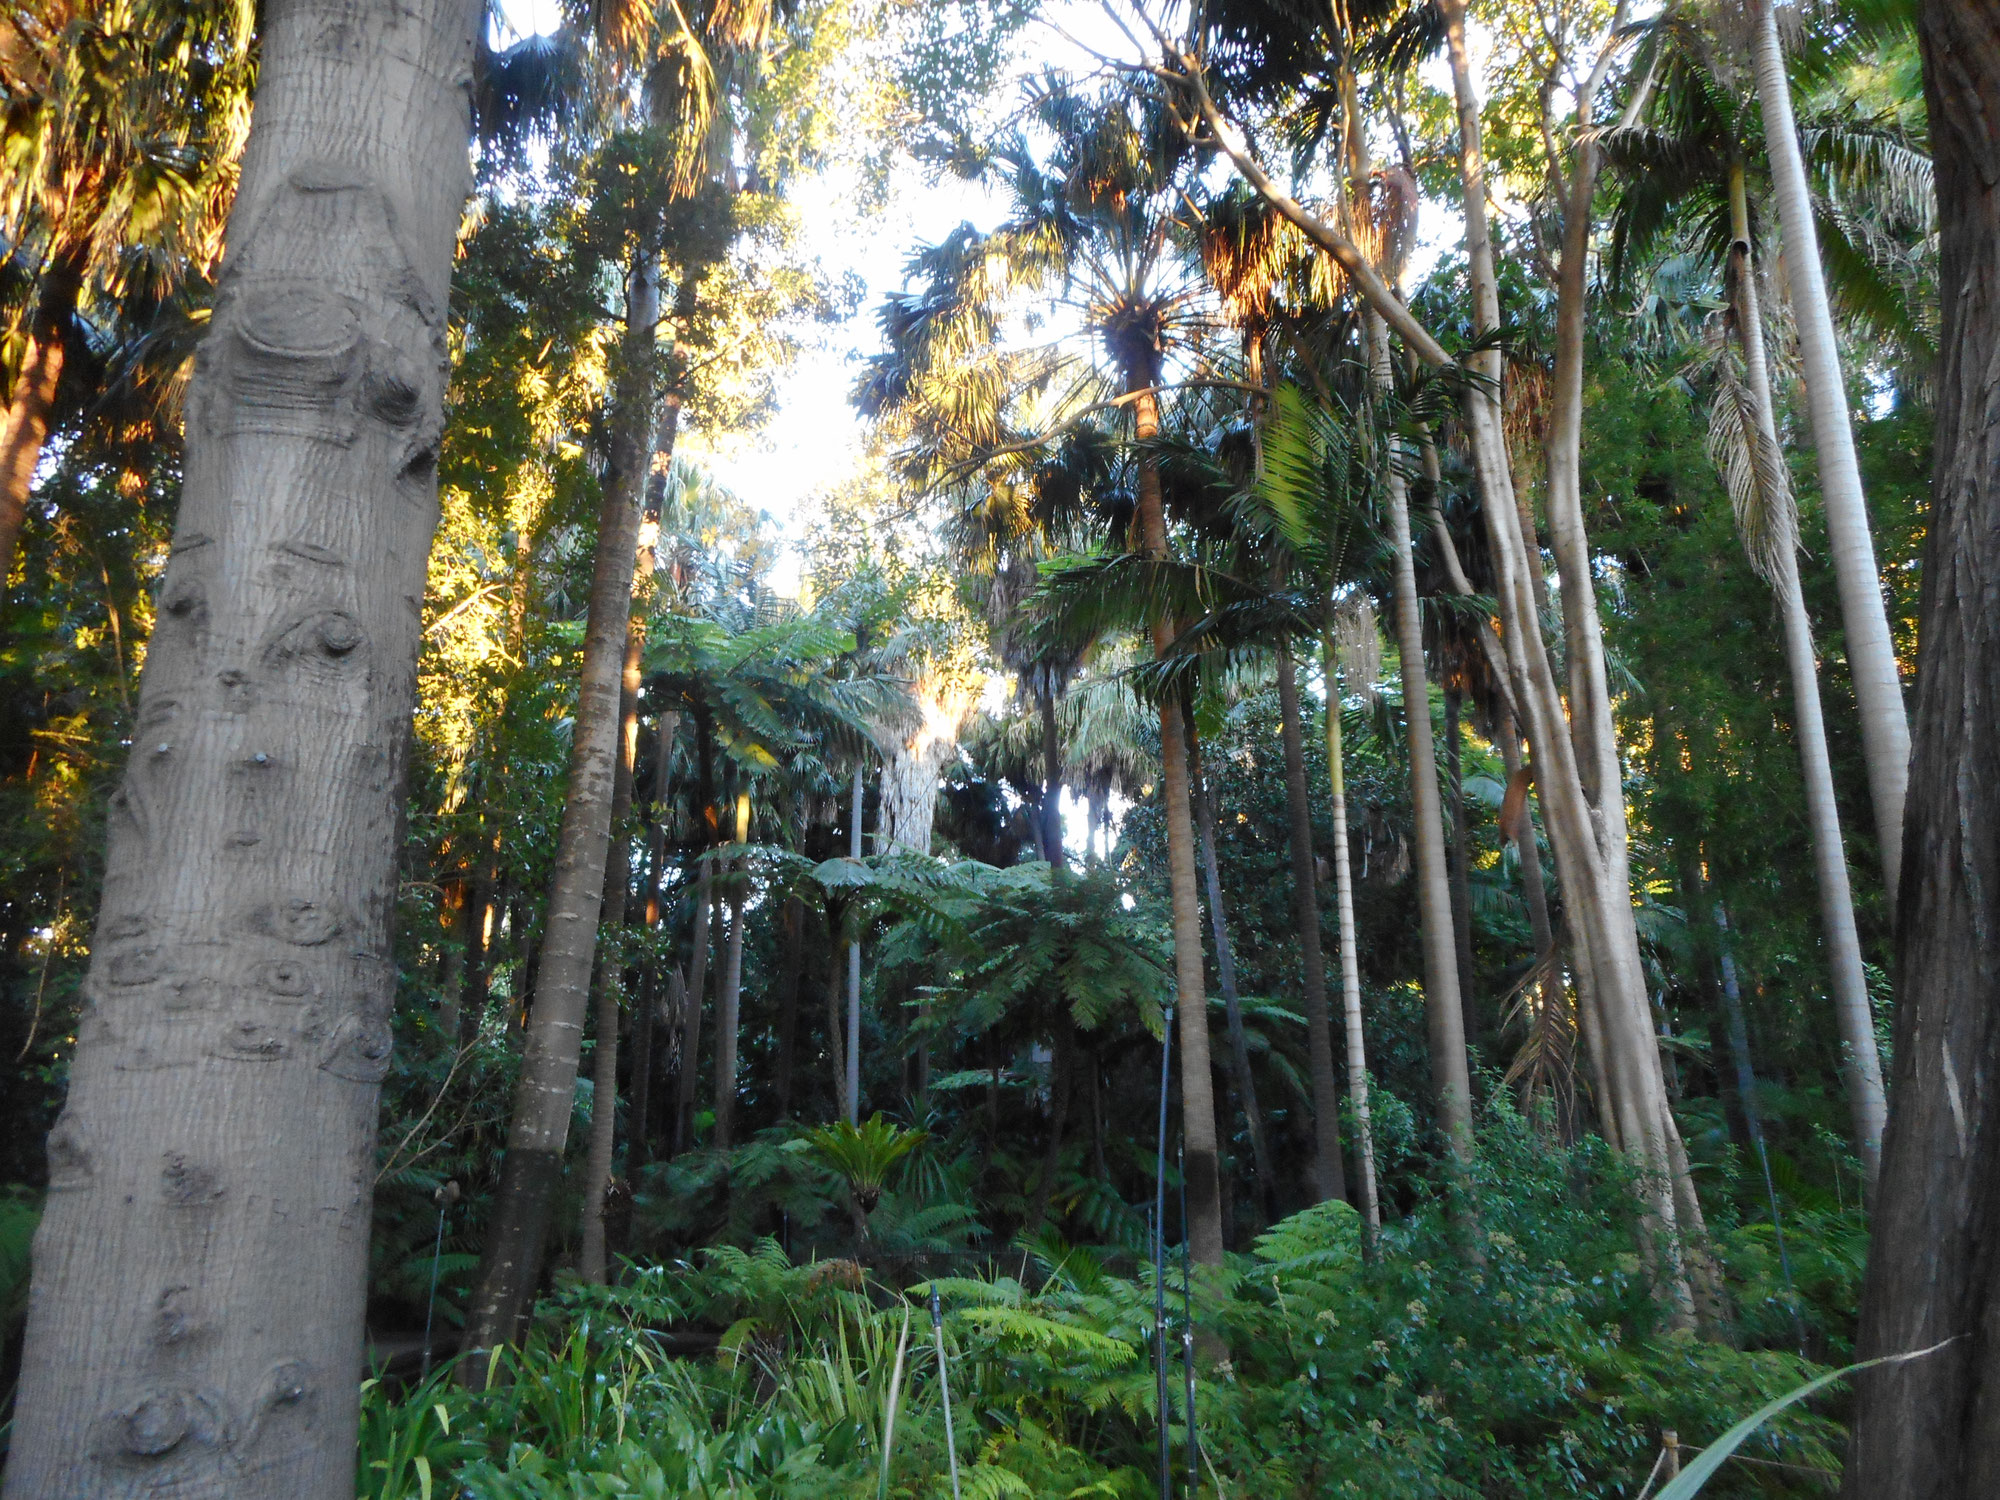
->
xmin=464 ymin=246 xmax=660 ymax=1360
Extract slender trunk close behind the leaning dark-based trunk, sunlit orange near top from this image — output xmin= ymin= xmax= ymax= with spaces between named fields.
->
xmin=576 ymin=628 xmax=650 ymax=1286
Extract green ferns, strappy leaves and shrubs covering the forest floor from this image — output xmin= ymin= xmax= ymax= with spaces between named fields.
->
xmin=360 ymin=1110 xmax=1852 ymax=1500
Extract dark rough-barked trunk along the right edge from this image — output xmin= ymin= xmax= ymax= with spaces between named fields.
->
xmin=1848 ymin=0 xmax=2000 ymax=1500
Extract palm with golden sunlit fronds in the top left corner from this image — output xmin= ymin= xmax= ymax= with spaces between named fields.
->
xmin=0 ymin=0 xmax=254 ymax=576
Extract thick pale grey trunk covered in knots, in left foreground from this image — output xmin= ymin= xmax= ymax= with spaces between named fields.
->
xmin=6 ymin=0 xmax=474 ymax=1500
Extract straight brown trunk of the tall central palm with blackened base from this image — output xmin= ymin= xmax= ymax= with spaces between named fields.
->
xmin=1126 ymin=370 xmax=1222 ymax=1266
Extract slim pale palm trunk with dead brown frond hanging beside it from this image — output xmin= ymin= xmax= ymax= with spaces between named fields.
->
xmin=1730 ymin=168 xmax=1888 ymax=1198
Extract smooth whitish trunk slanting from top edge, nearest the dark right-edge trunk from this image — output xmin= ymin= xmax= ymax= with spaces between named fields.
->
xmin=1744 ymin=0 xmax=1904 ymax=898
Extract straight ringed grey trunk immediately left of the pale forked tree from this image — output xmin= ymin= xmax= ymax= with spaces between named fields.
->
xmin=1362 ymin=302 xmax=1472 ymax=1162
